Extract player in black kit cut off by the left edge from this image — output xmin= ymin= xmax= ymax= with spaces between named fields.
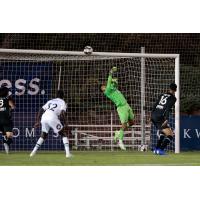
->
xmin=0 ymin=87 xmax=15 ymax=153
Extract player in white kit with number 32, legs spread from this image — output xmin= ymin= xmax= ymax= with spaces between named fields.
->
xmin=30 ymin=90 xmax=71 ymax=158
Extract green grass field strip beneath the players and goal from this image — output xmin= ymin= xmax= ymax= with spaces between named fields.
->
xmin=0 ymin=151 xmax=200 ymax=166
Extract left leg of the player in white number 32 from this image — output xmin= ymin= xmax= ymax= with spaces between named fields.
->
xmin=30 ymin=122 xmax=50 ymax=157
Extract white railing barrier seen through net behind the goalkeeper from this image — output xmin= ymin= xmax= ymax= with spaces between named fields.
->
xmin=69 ymin=125 xmax=151 ymax=150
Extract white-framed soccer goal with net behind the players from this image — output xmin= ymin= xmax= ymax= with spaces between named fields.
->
xmin=0 ymin=49 xmax=180 ymax=153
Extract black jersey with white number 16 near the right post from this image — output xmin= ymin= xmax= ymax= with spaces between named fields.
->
xmin=152 ymin=92 xmax=176 ymax=119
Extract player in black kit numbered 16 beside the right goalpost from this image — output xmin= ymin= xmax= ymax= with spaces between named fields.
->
xmin=151 ymin=83 xmax=177 ymax=155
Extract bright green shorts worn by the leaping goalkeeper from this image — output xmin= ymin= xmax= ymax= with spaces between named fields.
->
xmin=117 ymin=103 xmax=134 ymax=124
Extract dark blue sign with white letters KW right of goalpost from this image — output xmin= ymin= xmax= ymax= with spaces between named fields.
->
xmin=180 ymin=116 xmax=200 ymax=151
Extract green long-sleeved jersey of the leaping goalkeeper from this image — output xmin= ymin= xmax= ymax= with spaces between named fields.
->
xmin=104 ymin=75 xmax=127 ymax=107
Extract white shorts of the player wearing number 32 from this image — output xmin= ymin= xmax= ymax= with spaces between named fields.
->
xmin=41 ymin=117 xmax=63 ymax=133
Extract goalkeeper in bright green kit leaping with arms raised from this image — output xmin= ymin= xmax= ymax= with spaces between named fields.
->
xmin=101 ymin=67 xmax=134 ymax=150
